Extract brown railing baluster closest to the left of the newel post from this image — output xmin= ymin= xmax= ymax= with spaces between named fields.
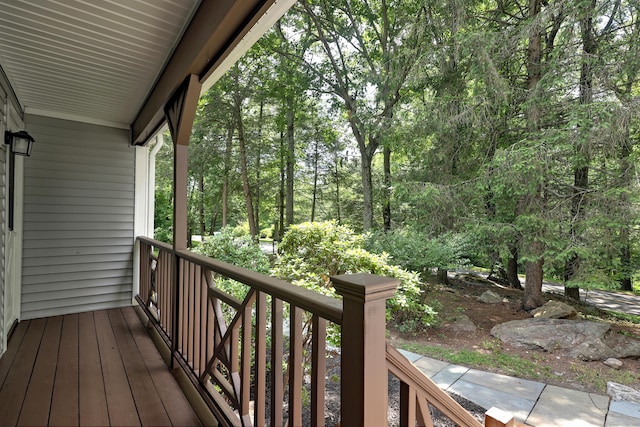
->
xmin=311 ymin=315 xmax=327 ymax=427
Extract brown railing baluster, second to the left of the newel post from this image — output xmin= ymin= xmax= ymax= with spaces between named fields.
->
xmin=289 ymin=305 xmax=303 ymax=427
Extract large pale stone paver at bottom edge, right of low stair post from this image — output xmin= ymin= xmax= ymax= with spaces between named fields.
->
xmin=526 ymin=385 xmax=609 ymax=427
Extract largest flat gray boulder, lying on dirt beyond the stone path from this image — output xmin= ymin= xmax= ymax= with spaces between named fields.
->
xmin=491 ymin=318 xmax=615 ymax=360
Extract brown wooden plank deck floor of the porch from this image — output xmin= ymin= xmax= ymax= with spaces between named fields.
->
xmin=0 ymin=307 xmax=200 ymax=426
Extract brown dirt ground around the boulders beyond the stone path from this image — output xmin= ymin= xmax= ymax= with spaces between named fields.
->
xmin=391 ymin=277 xmax=640 ymax=394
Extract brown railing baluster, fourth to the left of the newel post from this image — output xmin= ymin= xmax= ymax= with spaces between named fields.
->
xmin=253 ymin=291 xmax=267 ymax=426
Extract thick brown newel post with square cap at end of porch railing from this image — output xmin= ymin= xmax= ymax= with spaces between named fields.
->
xmin=331 ymin=273 xmax=400 ymax=427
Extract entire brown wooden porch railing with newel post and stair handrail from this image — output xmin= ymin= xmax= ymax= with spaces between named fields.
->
xmin=136 ymin=237 xmax=516 ymax=426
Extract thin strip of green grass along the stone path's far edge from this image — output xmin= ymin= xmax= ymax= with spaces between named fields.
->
xmin=399 ymin=340 xmax=558 ymax=379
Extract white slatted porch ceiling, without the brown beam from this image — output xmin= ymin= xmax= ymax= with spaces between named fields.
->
xmin=0 ymin=0 xmax=200 ymax=128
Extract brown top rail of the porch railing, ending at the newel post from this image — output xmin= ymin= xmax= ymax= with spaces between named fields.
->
xmin=138 ymin=237 xmax=342 ymax=325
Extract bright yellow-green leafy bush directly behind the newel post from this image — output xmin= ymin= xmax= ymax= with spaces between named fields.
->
xmin=273 ymin=221 xmax=436 ymax=338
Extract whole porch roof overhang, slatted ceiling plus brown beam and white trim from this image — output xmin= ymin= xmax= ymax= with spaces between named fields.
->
xmin=0 ymin=0 xmax=294 ymax=145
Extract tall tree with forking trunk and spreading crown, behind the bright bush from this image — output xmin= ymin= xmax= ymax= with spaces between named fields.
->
xmin=295 ymin=0 xmax=425 ymax=230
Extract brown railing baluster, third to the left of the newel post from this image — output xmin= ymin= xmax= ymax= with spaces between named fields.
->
xmin=271 ymin=297 xmax=284 ymax=426
